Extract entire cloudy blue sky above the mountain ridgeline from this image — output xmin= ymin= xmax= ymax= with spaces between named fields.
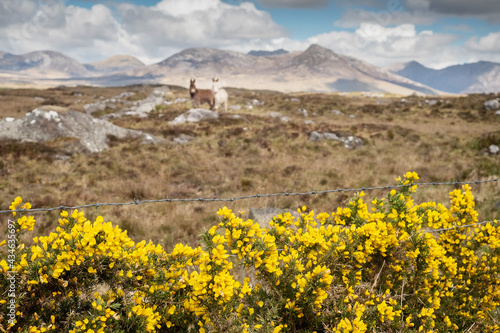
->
xmin=0 ymin=0 xmax=500 ymax=68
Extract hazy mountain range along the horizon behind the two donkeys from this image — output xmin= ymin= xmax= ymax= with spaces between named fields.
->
xmin=0 ymin=44 xmax=500 ymax=95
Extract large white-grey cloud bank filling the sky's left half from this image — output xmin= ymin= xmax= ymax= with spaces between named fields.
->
xmin=0 ymin=0 xmax=288 ymax=63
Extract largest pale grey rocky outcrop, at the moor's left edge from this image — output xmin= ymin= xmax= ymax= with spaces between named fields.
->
xmin=0 ymin=107 xmax=165 ymax=153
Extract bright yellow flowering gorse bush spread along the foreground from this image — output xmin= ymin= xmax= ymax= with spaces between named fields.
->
xmin=0 ymin=172 xmax=500 ymax=333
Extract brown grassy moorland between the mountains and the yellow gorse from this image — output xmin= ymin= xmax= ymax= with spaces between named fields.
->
xmin=0 ymin=86 xmax=500 ymax=249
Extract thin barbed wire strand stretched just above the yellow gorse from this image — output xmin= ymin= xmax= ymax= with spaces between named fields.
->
xmin=0 ymin=178 xmax=499 ymax=214
